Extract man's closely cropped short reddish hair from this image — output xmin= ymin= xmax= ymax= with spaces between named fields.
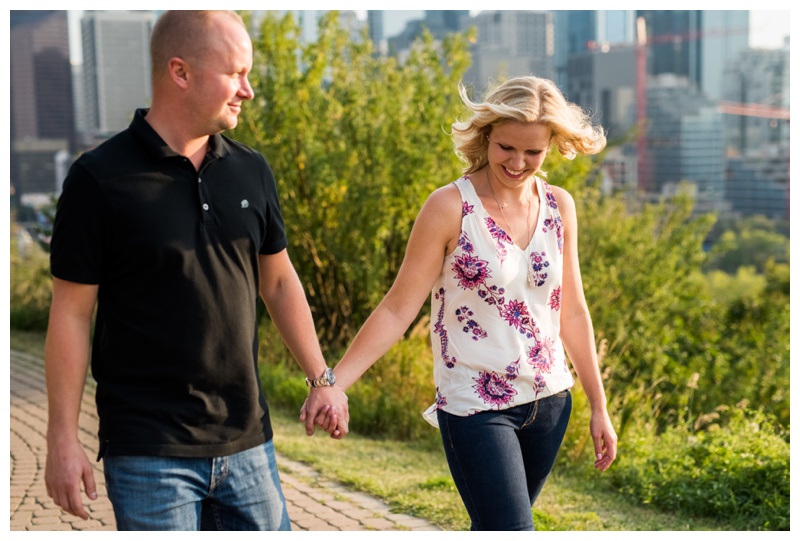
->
xmin=150 ymin=10 xmax=244 ymax=81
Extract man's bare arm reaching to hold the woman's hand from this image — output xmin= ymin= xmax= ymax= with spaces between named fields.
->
xmin=258 ymin=249 xmax=350 ymax=439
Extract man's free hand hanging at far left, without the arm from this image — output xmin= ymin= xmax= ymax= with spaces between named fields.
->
xmin=44 ymin=434 xmax=97 ymax=520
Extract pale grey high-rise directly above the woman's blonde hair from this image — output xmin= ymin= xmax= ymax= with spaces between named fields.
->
xmin=464 ymin=11 xmax=555 ymax=90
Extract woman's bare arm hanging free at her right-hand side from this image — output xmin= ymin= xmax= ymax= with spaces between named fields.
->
xmin=552 ymin=186 xmax=617 ymax=471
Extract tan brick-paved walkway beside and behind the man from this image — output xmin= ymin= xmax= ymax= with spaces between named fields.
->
xmin=9 ymin=351 xmax=439 ymax=531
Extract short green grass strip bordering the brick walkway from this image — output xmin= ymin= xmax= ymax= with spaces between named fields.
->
xmin=10 ymin=329 xmax=729 ymax=531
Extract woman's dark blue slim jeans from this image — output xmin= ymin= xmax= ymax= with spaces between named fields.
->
xmin=437 ymin=391 xmax=572 ymax=531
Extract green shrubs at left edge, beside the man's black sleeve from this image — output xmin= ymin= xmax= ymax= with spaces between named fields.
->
xmin=9 ymin=223 xmax=52 ymax=331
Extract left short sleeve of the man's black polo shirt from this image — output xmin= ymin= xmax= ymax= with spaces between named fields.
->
xmin=50 ymin=162 xmax=109 ymax=285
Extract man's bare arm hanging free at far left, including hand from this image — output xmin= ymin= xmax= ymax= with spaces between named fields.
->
xmin=44 ymin=278 xmax=97 ymax=520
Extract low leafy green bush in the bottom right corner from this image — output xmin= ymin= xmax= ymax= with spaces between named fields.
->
xmin=608 ymin=408 xmax=789 ymax=530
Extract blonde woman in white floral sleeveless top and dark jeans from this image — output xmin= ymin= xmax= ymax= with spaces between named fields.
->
xmin=302 ymin=77 xmax=617 ymax=530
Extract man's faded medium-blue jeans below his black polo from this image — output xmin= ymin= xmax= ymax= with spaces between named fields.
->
xmin=103 ymin=441 xmax=291 ymax=531
